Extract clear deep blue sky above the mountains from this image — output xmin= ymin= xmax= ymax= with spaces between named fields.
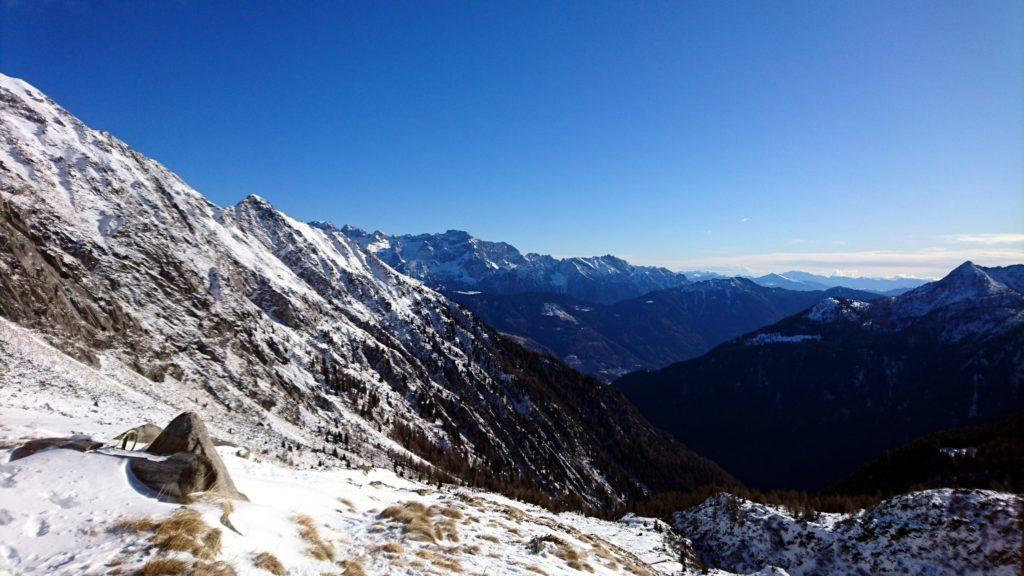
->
xmin=0 ymin=0 xmax=1024 ymax=276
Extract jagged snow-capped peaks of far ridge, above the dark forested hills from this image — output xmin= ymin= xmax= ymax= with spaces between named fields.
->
xmin=341 ymin=225 xmax=686 ymax=303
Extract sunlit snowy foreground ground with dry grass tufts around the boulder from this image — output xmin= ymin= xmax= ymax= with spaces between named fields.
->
xmin=0 ymin=405 xmax=753 ymax=576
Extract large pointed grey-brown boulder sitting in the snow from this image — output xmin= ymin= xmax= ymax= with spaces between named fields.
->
xmin=131 ymin=412 xmax=248 ymax=500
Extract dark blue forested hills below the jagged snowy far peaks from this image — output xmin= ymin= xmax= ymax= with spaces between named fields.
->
xmin=449 ymin=278 xmax=882 ymax=379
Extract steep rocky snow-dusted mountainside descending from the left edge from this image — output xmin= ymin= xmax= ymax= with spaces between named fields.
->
xmin=0 ymin=71 xmax=729 ymax=505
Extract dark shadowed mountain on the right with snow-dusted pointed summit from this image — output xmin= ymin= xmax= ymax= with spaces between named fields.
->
xmin=615 ymin=262 xmax=1024 ymax=489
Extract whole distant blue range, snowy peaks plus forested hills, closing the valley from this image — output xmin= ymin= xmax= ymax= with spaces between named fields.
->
xmin=335 ymin=222 xmax=937 ymax=379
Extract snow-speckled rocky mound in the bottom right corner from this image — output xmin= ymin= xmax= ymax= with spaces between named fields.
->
xmin=676 ymin=489 xmax=1024 ymax=576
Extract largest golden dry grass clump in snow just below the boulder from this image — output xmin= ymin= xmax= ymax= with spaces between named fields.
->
xmin=114 ymin=508 xmax=220 ymax=560
